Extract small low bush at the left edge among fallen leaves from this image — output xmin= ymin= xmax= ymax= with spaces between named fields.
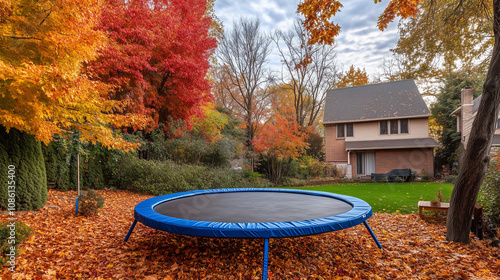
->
xmin=0 ymin=221 xmax=31 ymax=265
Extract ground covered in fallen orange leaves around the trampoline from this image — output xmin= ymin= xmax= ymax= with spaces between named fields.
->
xmin=0 ymin=190 xmax=500 ymax=280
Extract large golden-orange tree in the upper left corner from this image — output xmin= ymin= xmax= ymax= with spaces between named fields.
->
xmin=0 ymin=0 xmax=148 ymax=150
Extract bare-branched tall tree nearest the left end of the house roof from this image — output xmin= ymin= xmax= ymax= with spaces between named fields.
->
xmin=273 ymin=20 xmax=337 ymax=128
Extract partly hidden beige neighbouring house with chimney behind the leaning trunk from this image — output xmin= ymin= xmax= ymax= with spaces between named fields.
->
xmin=451 ymin=87 xmax=500 ymax=150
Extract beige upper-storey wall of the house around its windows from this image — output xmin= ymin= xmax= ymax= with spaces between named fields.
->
xmin=346 ymin=118 xmax=429 ymax=141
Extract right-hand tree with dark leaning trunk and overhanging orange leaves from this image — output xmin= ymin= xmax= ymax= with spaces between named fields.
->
xmin=298 ymin=0 xmax=500 ymax=243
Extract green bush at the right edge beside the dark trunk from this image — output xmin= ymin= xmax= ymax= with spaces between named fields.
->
xmin=477 ymin=158 xmax=500 ymax=227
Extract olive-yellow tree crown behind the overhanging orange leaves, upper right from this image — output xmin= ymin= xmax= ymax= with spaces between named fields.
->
xmin=392 ymin=0 xmax=494 ymax=78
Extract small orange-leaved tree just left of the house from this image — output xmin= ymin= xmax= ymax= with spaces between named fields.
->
xmin=252 ymin=114 xmax=308 ymax=184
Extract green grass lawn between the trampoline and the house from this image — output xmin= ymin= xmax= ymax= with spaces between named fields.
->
xmin=282 ymin=182 xmax=453 ymax=214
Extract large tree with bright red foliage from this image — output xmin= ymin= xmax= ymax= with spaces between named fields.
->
xmin=88 ymin=0 xmax=216 ymax=128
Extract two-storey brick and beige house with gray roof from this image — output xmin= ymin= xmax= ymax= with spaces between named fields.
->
xmin=323 ymin=79 xmax=439 ymax=178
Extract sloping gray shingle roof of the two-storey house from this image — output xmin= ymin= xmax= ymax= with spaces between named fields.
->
xmin=323 ymin=79 xmax=430 ymax=123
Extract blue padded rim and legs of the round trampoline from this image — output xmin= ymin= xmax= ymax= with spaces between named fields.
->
xmin=124 ymin=188 xmax=382 ymax=279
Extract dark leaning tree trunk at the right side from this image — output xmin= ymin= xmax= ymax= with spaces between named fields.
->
xmin=446 ymin=0 xmax=500 ymax=243
